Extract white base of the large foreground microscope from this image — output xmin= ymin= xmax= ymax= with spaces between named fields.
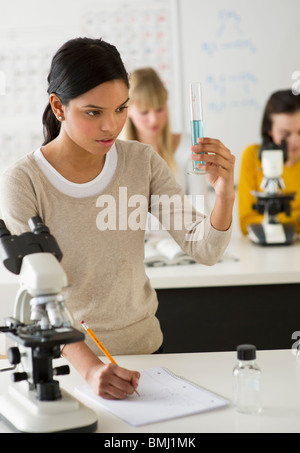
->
xmin=0 ymin=383 xmax=98 ymax=433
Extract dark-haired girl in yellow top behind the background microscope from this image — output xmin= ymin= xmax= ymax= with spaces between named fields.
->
xmin=238 ymin=90 xmax=300 ymax=234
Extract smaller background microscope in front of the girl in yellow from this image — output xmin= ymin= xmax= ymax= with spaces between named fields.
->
xmin=248 ymin=140 xmax=296 ymax=245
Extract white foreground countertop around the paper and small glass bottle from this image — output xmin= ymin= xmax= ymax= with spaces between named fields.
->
xmin=0 ymin=350 xmax=300 ymax=433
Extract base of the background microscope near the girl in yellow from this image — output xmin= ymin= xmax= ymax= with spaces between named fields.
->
xmin=248 ymin=223 xmax=296 ymax=245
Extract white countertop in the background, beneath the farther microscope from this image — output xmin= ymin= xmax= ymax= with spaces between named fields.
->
xmin=146 ymin=237 xmax=300 ymax=289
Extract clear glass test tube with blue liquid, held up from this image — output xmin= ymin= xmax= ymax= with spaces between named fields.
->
xmin=189 ymin=82 xmax=207 ymax=175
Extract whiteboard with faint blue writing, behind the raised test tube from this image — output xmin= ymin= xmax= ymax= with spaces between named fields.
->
xmin=179 ymin=0 xmax=300 ymax=181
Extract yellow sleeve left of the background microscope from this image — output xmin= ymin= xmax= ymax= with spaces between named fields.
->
xmin=238 ymin=145 xmax=263 ymax=234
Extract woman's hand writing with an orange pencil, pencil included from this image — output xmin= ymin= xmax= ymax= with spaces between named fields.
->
xmin=81 ymin=321 xmax=139 ymax=399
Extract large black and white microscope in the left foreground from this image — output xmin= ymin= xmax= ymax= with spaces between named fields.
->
xmin=0 ymin=217 xmax=97 ymax=433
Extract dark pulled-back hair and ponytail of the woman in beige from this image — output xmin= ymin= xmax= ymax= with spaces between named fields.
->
xmin=42 ymin=38 xmax=129 ymax=145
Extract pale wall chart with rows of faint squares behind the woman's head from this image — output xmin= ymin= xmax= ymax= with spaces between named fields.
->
xmin=0 ymin=0 xmax=182 ymax=172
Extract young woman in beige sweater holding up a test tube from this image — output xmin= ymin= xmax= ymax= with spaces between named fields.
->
xmin=0 ymin=38 xmax=234 ymax=399
